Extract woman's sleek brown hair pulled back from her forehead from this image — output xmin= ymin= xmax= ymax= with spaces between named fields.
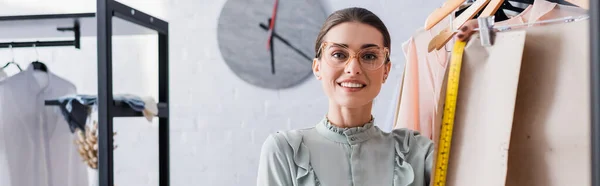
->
xmin=315 ymin=7 xmax=392 ymax=62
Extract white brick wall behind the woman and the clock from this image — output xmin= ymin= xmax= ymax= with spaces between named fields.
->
xmin=0 ymin=0 xmax=443 ymax=186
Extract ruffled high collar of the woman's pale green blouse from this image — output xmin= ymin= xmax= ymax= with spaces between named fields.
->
xmin=316 ymin=117 xmax=377 ymax=144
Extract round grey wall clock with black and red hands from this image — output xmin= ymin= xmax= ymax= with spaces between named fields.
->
xmin=217 ymin=0 xmax=327 ymax=89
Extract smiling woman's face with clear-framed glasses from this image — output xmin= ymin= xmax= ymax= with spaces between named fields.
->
xmin=313 ymin=22 xmax=391 ymax=108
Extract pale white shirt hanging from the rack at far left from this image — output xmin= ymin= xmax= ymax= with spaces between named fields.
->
xmin=0 ymin=65 xmax=88 ymax=186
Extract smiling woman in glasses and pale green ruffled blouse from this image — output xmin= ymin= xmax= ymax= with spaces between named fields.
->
xmin=257 ymin=8 xmax=433 ymax=186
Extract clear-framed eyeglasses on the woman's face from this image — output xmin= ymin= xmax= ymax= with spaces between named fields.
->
xmin=317 ymin=42 xmax=389 ymax=70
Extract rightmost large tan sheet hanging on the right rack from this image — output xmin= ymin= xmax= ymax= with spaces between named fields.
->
xmin=507 ymin=16 xmax=591 ymax=186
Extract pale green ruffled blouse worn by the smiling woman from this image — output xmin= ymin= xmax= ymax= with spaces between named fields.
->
xmin=257 ymin=119 xmax=434 ymax=186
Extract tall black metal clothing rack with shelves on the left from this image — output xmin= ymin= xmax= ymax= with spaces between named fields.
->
xmin=0 ymin=0 xmax=170 ymax=186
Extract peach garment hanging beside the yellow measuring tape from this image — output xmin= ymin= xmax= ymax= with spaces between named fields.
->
xmin=394 ymin=17 xmax=453 ymax=139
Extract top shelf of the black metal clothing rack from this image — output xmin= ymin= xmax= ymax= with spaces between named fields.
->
xmin=0 ymin=8 xmax=163 ymax=40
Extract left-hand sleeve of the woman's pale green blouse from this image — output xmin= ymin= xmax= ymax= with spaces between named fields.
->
xmin=256 ymin=134 xmax=293 ymax=186
